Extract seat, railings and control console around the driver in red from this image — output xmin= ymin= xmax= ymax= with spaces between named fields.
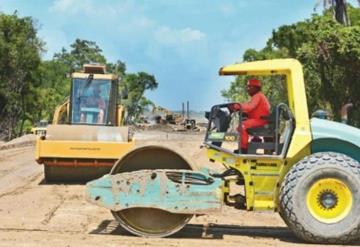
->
xmin=204 ymin=103 xmax=294 ymax=157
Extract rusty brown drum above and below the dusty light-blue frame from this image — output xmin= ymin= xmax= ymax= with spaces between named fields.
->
xmin=110 ymin=146 xmax=193 ymax=237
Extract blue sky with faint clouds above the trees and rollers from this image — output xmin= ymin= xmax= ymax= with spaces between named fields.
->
xmin=0 ymin=0 xmax=316 ymax=111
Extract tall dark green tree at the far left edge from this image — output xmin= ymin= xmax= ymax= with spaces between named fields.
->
xmin=0 ymin=12 xmax=44 ymax=139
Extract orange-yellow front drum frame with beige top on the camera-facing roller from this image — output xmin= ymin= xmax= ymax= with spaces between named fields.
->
xmin=36 ymin=125 xmax=135 ymax=167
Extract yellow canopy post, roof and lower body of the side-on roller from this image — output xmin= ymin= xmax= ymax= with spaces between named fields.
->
xmin=207 ymin=59 xmax=312 ymax=210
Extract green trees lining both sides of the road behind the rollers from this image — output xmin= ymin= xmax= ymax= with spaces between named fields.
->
xmin=0 ymin=5 xmax=360 ymax=140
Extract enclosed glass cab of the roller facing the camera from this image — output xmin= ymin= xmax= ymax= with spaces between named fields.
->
xmin=70 ymin=65 xmax=118 ymax=126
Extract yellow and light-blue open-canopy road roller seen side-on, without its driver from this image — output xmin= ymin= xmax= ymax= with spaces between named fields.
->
xmin=86 ymin=59 xmax=360 ymax=244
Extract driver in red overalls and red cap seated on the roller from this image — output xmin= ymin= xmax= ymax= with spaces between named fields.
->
xmin=230 ymin=78 xmax=270 ymax=154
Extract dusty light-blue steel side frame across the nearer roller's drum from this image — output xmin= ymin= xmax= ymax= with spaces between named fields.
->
xmin=86 ymin=170 xmax=223 ymax=214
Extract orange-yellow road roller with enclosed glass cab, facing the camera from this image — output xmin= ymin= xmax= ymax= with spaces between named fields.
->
xmin=35 ymin=64 xmax=134 ymax=182
